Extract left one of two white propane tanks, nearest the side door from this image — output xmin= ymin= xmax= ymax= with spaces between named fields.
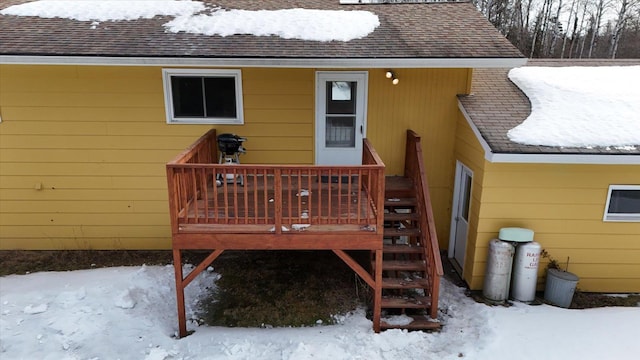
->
xmin=482 ymin=239 xmax=515 ymax=302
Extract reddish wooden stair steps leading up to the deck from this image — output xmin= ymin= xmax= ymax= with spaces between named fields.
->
xmin=371 ymin=177 xmax=440 ymax=330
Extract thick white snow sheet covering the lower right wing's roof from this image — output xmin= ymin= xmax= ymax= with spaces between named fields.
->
xmin=507 ymin=66 xmax=640 ymax=150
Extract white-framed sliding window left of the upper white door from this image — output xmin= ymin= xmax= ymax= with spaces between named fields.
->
xmin=162 ymin=69 xmax=244 ymax=125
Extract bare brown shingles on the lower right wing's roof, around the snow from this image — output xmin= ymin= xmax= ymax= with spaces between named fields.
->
xmin=458 ymin=59 xmax=640 ymax=155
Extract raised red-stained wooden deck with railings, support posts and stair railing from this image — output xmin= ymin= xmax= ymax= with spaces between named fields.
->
xmin=167 ymin=130 xmax=441 ymax=337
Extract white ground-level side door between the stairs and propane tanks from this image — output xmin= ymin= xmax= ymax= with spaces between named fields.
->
xmin=449 ymin=162 xmax=473 ymax=270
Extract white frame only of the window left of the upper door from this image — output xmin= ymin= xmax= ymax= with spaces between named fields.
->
xmin=162 ymin=69 xmax=244 ymax=125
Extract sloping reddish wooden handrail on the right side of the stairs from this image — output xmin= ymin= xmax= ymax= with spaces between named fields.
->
xmin=404 ymin=130 xmax=443 ymax=319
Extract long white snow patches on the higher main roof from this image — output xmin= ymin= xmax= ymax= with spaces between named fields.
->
xmin=0 ymin=0 xmax=380 ymax=41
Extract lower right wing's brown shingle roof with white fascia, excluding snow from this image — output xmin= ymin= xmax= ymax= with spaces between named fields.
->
xmin=458 ymin=59 xmax=640 ymax=164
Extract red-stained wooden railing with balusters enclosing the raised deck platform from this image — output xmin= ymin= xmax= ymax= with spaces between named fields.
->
xmin=167 ymin=130 xmax=384 ymax=234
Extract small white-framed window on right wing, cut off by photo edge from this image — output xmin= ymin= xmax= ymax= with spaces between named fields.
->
xmin=603 ymin=185 xmax=640 ymax=222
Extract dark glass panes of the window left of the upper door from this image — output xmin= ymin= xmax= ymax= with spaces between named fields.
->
xmin=171 ymin=76 xmax=237 ymax=118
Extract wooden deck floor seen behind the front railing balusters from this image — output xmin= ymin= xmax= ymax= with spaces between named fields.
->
xmin=180 ymin=174 xmax=376 ymax=231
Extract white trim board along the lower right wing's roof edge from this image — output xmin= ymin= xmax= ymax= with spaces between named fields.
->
xmin=458 ymin=100 xmax=640 ymax=165
